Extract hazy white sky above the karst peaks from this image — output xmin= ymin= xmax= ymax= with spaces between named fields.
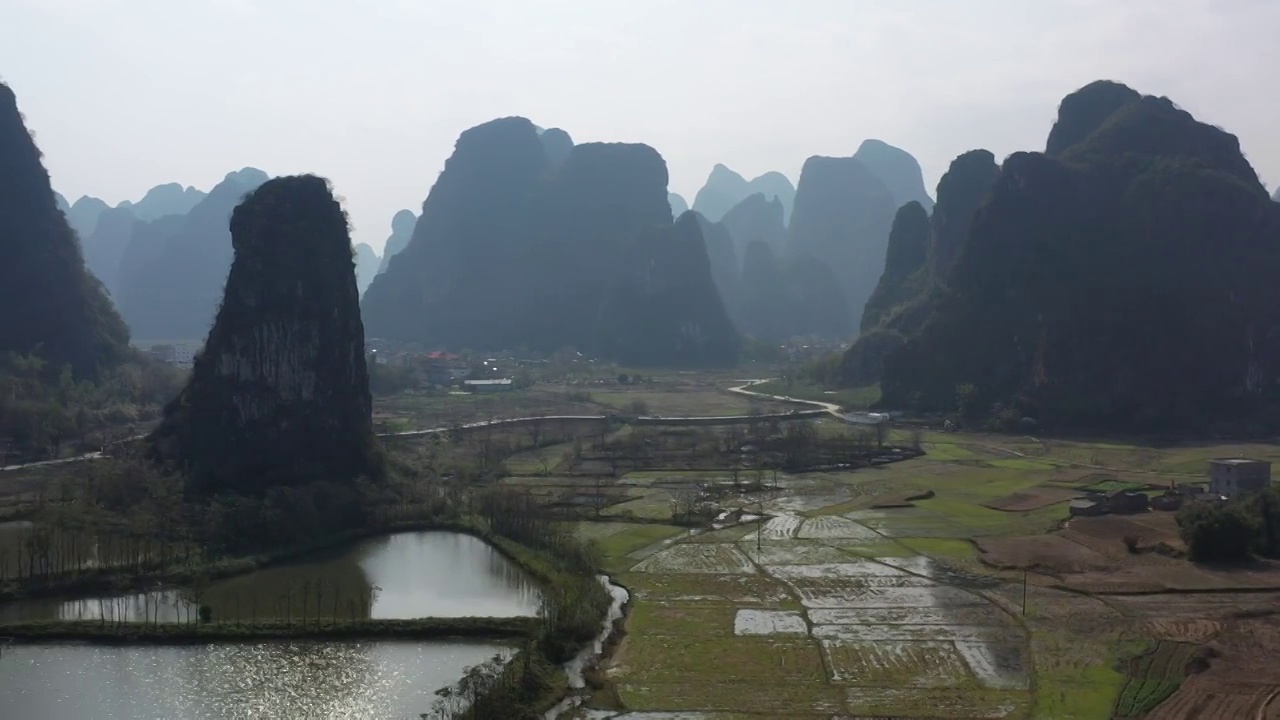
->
xmin=0 ymin=0 xmax=1280 ymax=251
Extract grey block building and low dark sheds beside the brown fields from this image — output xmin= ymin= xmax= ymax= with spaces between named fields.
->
xmin=1070 ymin=457 xmax=1271 ymax=516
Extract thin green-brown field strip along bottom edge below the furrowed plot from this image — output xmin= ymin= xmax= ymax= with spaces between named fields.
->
xmin=845 ymin=687 xmax=1030 ymax=720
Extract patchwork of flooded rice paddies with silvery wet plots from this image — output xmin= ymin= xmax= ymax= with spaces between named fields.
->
xmin=616 ymin=501 xmax=1032 ymax=719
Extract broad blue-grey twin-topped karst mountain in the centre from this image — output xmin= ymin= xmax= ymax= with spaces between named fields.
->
xmin=364 ymin=118 xmax=736 ymax=364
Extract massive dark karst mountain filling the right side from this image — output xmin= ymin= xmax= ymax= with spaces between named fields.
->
xmin=882 ymin=83 xmax=1280 ymax=430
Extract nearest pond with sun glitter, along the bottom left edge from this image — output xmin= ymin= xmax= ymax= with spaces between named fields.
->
xmin=0 ymin=642 xmax=511 ymax=720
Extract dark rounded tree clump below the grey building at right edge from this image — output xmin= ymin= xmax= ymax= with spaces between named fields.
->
xmin=1178 ymin=488 xmax=1280 ymax=562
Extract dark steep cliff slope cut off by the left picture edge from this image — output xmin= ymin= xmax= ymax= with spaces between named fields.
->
xmin=0 ymin=83 xmax=129 ymax=378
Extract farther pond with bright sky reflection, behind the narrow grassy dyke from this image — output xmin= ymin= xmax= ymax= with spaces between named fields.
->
xmin=0 ymin=532 xmax=541 ymax=624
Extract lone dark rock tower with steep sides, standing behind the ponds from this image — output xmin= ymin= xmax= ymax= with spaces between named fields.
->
xmin=150 ymin=176 xmax=372 ymax=493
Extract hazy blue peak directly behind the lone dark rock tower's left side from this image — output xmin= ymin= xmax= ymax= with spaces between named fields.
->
xmin=116 ymin=168 xmax=268 ymax=340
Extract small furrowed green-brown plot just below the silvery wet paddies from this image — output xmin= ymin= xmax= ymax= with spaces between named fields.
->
xmin=822 ymin=639 xmax=969 ymax=688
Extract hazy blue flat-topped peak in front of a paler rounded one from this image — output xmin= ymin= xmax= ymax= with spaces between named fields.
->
xmin=788 ymin=158 xmax=897 ymax=318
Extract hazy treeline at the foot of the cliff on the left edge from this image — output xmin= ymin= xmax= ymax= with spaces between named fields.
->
xmin=0 ymin=352 xmax=186 ymax=465
